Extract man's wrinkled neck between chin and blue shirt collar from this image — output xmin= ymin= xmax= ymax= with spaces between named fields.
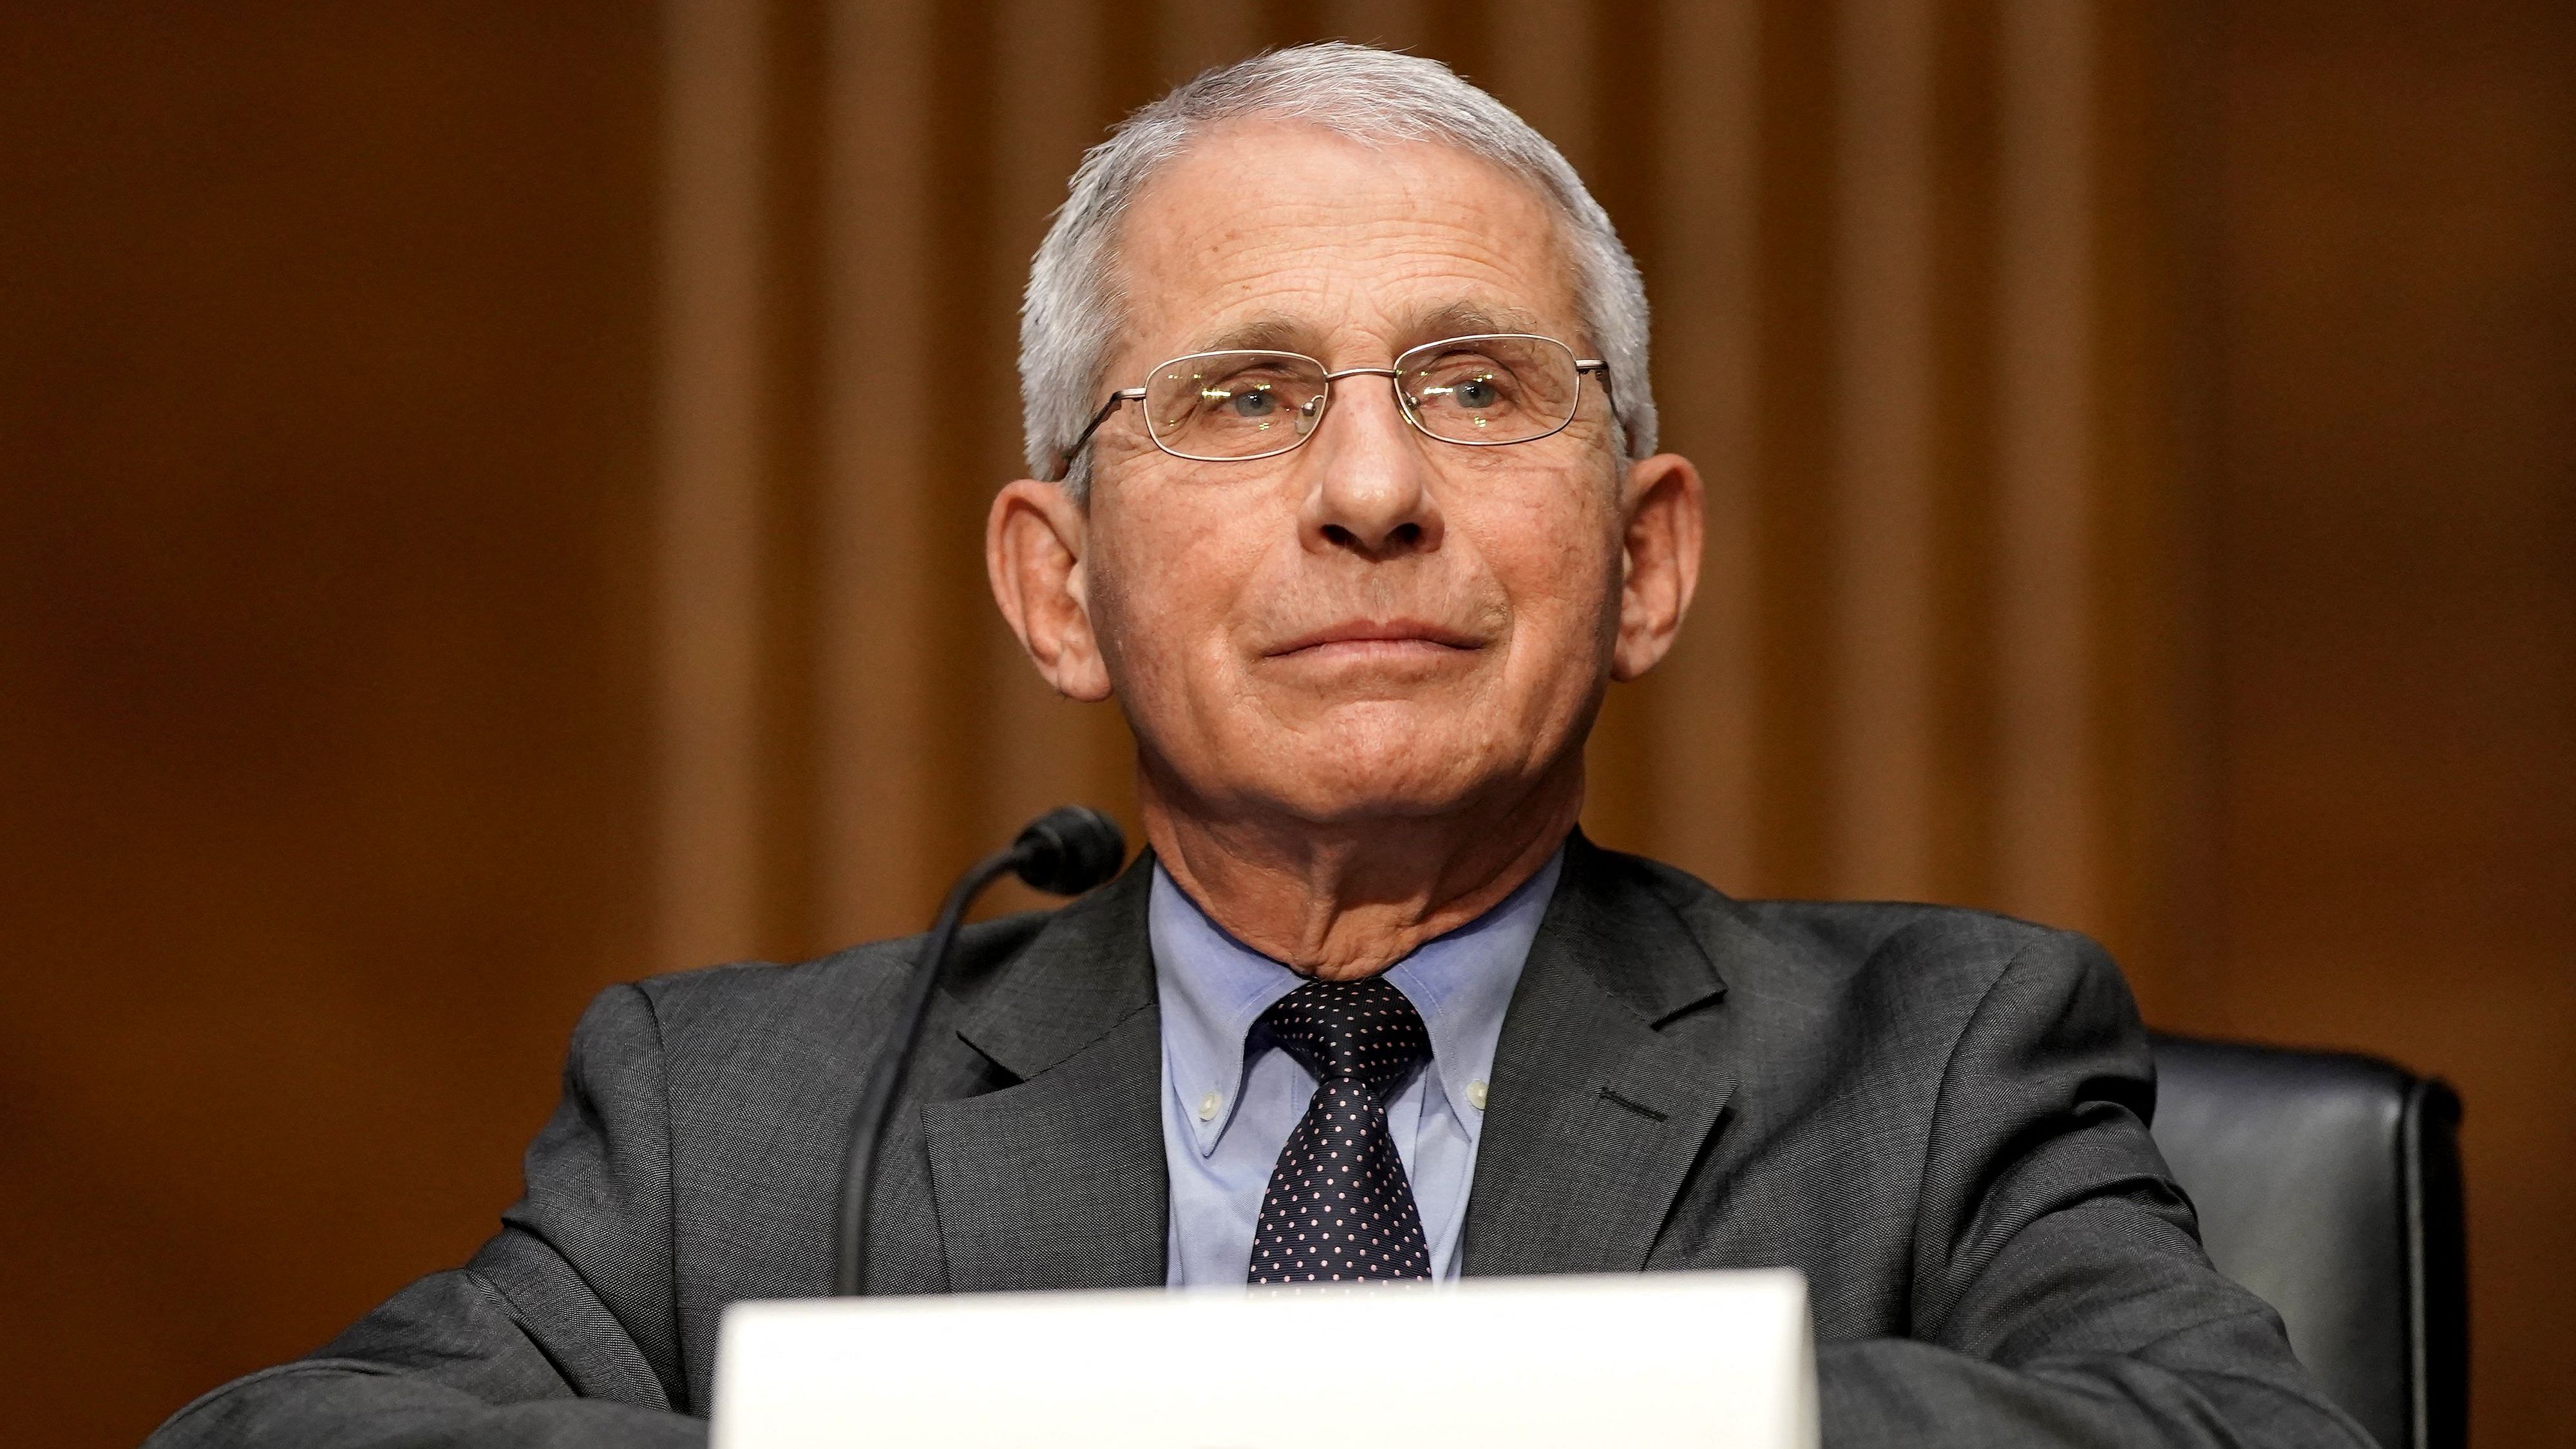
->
xmin=1136 ymin=750 xmax=1584 ymax=980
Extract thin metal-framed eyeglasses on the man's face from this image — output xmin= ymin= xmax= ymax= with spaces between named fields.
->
xmin=1056 ymin=332 xmax=1618 ymax=480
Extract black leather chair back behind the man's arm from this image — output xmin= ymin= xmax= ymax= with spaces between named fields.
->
xmin=2156 ymin=1036 xmax=2468 ymax=1449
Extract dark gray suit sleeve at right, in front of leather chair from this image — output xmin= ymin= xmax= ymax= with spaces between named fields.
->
xmin=1816 ymin=933 xmax=2372 ymax=1449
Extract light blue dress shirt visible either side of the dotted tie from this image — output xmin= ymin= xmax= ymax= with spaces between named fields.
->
xmin=1146 ymin=851 xmax=1564 ymax=1287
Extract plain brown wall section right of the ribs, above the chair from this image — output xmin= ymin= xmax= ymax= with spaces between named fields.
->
xmin=2195 ymin=0 xmax=2576 ymax=1446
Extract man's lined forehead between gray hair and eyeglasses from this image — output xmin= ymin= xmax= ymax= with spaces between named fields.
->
xmin=1118 ymin=121 xmax=1582 ymax=366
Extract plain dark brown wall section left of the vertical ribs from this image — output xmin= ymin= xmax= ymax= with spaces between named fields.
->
xmin=0 ymin=3 xmax=659 ymax=1449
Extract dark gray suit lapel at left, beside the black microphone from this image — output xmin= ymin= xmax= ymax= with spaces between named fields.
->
xmin=922 ymin=856 xmax=1170 ymax=1292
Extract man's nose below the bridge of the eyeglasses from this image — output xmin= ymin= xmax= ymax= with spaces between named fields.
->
xmin=1298 ymin=374 xmax=1440 ymax=560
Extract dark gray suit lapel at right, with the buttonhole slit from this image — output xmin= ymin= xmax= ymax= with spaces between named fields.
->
xmin=1466 ymin=833 xmax=1734 ymax=1274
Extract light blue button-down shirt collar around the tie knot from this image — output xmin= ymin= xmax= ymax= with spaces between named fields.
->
xmin=1146 ymin=848 xmax=1566 ymax=1158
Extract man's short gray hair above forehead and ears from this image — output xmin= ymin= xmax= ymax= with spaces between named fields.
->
xmin=1020 ymin=41 xmax=1654 ymax=498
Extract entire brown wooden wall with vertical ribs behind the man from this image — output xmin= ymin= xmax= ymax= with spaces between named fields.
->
xmin=0 ymin=0 xmax=2576 ymax=1446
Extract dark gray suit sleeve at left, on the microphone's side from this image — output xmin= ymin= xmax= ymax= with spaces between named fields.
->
xmin=147 ymin=985 xmax=706 ymax=1449
